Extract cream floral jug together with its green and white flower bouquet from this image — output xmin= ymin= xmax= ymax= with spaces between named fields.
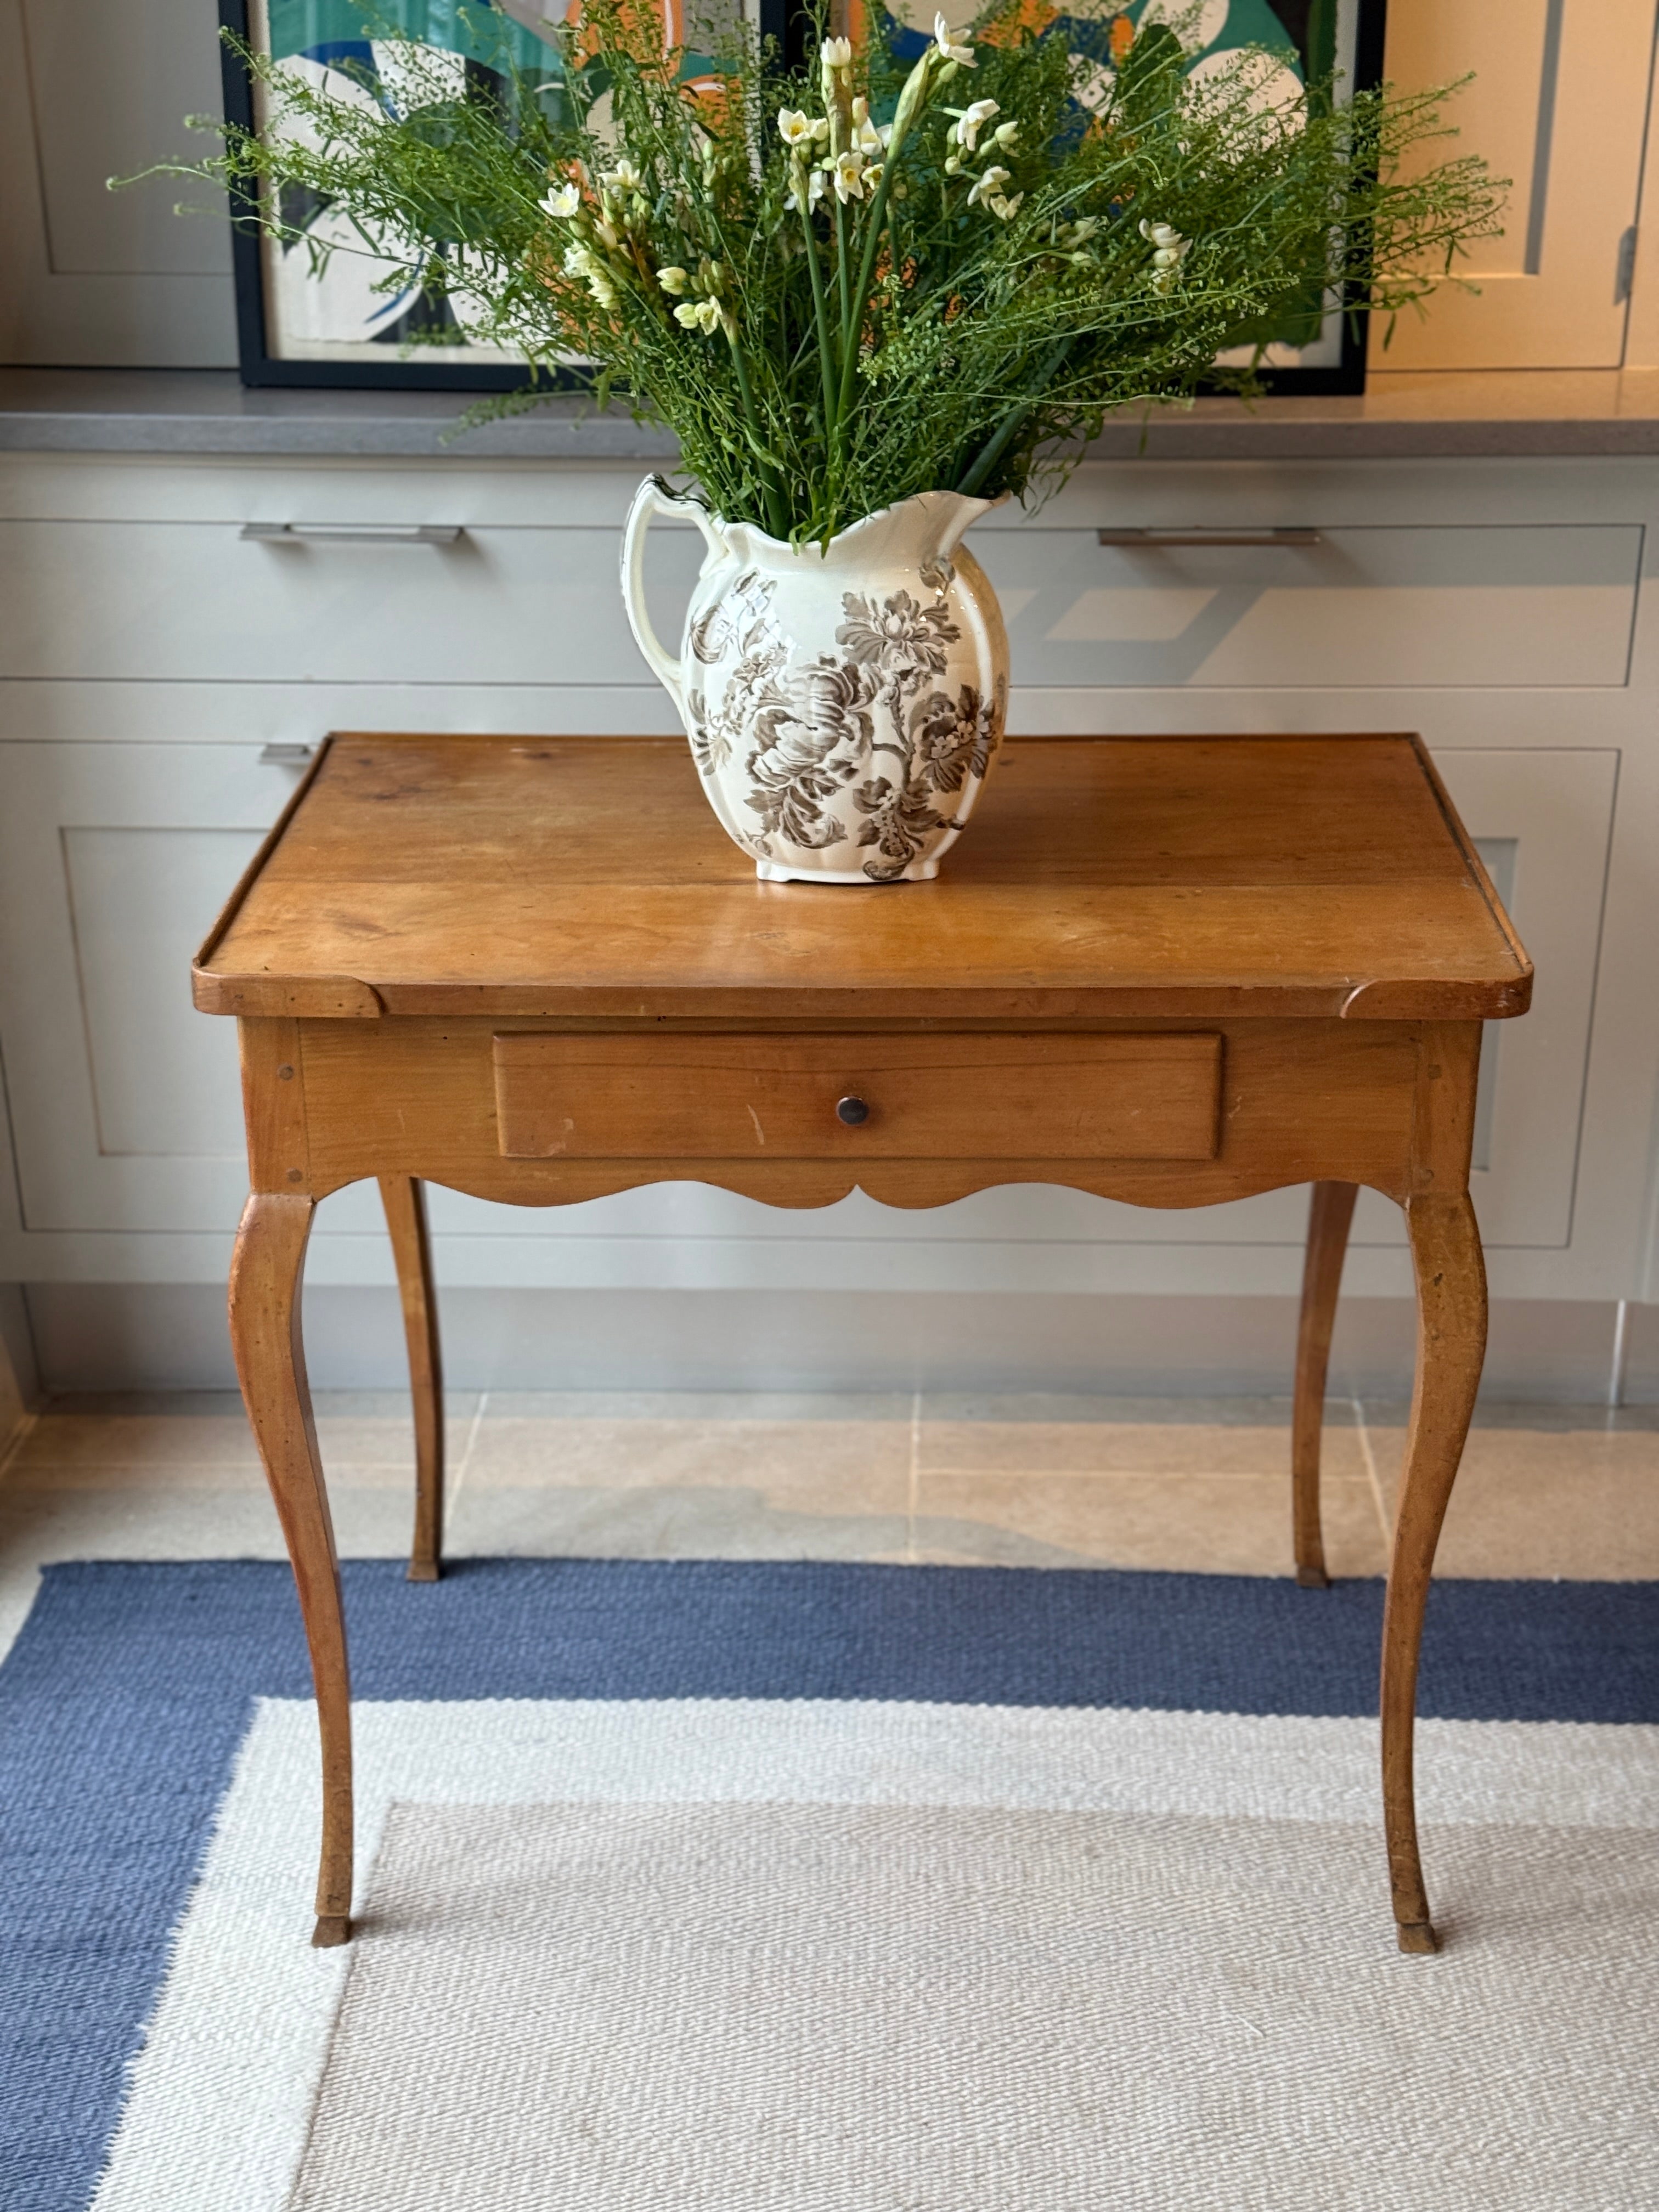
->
xmin=159 ymin=13 xmax=1498 ymax=883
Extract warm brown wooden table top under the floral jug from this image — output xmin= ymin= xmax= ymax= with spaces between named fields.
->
xmin=195 ymin=732 xmax=1533 ymax=1024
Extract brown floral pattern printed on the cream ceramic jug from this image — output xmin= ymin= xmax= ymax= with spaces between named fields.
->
xmin=688 ymin=571 xmax=1002 ymax=883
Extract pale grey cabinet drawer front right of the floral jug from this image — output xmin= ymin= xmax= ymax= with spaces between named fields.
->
xmin=973 ymin=524 xmax=1641 ymax=690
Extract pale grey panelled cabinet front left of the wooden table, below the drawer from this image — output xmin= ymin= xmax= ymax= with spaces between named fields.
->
xmin=0 ymin=746 xmax=283 ymax=1230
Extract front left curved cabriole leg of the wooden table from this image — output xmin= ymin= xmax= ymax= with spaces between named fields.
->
xmin=230 ymin=1190 xmax=352 ymax=1944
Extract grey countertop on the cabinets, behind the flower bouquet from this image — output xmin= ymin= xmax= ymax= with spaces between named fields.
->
xmin=0 ymin=369 xmax=1659 ymax=460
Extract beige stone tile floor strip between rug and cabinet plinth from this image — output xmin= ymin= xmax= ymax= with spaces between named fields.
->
xmin=0 ymin=1393 xmax=1659 ymax=1637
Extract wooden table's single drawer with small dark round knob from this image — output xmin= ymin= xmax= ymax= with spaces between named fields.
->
xmin=495 ymin=1031 xmax=1221 ymax=1159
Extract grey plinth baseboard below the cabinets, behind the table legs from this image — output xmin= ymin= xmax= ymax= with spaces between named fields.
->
xmin=16 ymin=1283 xmax=1659 ymax=1404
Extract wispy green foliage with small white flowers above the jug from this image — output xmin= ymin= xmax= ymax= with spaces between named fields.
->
xmin=153 ymin=0 xmax=1500 ymax=540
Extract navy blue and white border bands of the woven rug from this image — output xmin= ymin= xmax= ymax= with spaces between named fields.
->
xmin=0 ymin=1562 xmax=1659 ymax=2212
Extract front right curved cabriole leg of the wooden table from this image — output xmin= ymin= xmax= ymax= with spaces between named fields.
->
xmin=1383 ymin=1192 xmax=1487 ymax=1951
